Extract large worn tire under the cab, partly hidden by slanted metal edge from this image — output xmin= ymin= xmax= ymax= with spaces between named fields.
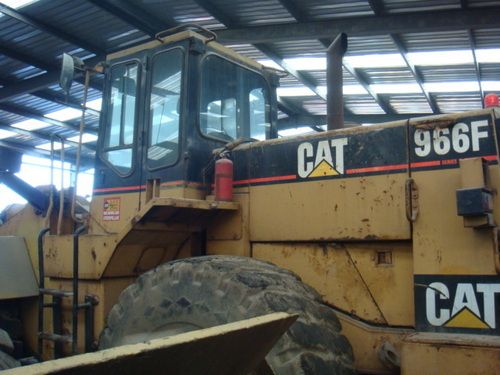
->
xmin=100 ymin=256 xmax=354 ymax=375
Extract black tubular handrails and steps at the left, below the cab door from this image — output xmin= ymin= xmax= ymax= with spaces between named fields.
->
xmin=38 ymin=226 xmax=98 ymax=358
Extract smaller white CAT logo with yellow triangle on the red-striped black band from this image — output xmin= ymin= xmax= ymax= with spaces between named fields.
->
xmin=297 ymin=138 xmax=347 ymax=178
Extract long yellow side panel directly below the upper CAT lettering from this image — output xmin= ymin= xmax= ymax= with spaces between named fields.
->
xmin=250 ymin=173 xmax=410 ymax=241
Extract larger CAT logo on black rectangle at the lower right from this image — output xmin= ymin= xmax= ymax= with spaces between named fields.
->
xmin=415 ymin=275 xmax=500 ymax=334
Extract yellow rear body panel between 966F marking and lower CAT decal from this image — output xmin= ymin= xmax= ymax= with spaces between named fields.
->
xmin=412 ymin=165 xmax=500 ymax=275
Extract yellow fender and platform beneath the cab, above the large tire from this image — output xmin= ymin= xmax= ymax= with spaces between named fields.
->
xmin=45 ymin=197 xmax=239 ymax=279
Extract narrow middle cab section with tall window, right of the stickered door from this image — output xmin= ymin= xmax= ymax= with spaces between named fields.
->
xmin=141 ymin=40 xmax=189 ymax=203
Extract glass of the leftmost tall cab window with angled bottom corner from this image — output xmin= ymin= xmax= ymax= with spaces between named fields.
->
xmin=103 ymin=62 xmax=138 ymax=174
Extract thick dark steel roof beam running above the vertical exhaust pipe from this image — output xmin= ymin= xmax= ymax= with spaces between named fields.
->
xmin=217 ymin=7 xmax=500 ymax=44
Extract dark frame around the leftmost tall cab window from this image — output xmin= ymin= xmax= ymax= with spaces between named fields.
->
xmin=98 ymin=57 xmax=143 ymax=177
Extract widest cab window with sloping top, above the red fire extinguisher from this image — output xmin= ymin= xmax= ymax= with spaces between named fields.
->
xmin=200 ymin=55 xmax=271 ymax=142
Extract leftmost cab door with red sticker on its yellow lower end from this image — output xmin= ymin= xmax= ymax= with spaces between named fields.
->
xmin=91 ymin=52 xmax=146 ymax=231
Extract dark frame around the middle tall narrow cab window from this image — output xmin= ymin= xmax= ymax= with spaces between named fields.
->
xmin=143 ymin=45 xmax=189 ymax=172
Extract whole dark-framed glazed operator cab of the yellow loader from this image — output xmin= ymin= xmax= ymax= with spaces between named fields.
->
xmin=94 ymin=31 xmax=277 ymax=203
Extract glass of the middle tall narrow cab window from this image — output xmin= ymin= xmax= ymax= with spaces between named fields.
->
xmin=147 ymin=48 xmax=184 ymax=169
